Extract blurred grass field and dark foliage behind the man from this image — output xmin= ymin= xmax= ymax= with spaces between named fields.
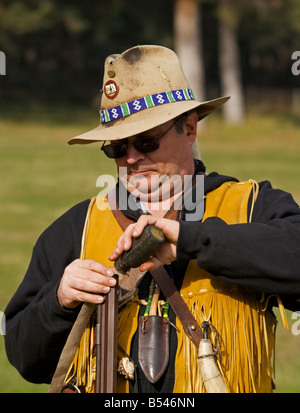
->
xmin=0 ymin=0 xmax=300 ymax=393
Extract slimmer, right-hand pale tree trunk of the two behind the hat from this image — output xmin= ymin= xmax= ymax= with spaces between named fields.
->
xmin=219 ymin=0 xmax=244 ymax=124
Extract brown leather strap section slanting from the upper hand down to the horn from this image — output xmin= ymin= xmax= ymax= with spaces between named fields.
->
xmin=150 ymin=267 xmax=203 ymax=347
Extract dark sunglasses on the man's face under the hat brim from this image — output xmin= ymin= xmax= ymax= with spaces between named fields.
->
xmin=101 ymin=116 xmax=182 ymax=159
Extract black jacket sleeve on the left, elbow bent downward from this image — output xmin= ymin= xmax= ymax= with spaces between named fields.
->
xmin=5 ymin=201 xmax=88 ymax=383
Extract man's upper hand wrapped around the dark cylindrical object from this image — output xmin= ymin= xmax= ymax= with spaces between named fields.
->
xmin=109 ymin=215 xmax=179 ymax=271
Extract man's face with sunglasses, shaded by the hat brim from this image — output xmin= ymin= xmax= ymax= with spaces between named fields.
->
xmin=115 ymin=113 xmax=197 ymax=201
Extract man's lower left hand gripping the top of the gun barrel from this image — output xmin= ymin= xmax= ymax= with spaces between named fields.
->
xmin=57 ymin=259 xmax=116 ymax=308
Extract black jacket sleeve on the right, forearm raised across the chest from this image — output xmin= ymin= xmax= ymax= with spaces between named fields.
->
xmin=177 ymin=181 xmax=300 ymax=309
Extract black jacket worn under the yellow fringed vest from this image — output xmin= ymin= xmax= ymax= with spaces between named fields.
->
xmin=5 ymin=165 xmax=300 ymax=392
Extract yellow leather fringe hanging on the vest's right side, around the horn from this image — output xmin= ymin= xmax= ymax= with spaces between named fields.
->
xmin=174 ymin=284 xmax=276 ymax=393
